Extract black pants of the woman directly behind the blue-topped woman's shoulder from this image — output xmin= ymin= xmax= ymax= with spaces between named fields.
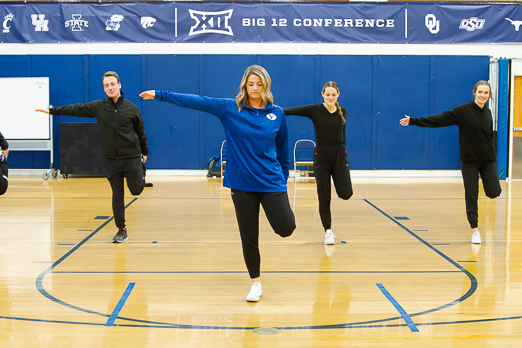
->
xmin=314 ymin=145 xmax=353 ymax=231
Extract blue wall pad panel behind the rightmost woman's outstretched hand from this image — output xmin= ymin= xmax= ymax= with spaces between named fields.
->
xmin=372 ymin=56 xmax=430 ymax=169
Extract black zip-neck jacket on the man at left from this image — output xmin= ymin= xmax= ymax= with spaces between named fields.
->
xmin=49 ymin=92 xmax=149 ymax=159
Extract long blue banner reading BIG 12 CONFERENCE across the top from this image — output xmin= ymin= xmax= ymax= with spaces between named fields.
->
xmin=0 ymin=2 xmax=522 ymax=44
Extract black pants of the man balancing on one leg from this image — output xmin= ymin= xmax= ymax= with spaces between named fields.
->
xmin=103 ymin=157 xmax=145 ymax=228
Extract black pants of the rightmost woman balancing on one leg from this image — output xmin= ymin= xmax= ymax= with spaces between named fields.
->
xmin=461 ymin=161 xmax=502 ymax=228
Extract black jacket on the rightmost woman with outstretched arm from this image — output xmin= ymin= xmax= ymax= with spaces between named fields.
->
xmin=410 ymin=100 xmax=497 ymax=163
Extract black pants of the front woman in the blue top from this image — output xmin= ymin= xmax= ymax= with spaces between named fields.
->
xmin=232 ymin=190 xmax=295 ymax=279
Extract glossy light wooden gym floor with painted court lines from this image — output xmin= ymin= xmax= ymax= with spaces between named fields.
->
xmin=0 ymin=176 xmax=522 ymax=348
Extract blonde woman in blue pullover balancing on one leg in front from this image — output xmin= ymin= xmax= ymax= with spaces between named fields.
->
xmin=140 ymin=65 xmax=295 ymax=302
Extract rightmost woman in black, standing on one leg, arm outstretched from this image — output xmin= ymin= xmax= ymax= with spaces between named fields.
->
xmin=399 ymin=81 xmax=502 ymax=244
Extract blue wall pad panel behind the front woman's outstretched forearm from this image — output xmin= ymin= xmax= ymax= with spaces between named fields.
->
xmin=144 ymin=55 xmax=205 ymax=169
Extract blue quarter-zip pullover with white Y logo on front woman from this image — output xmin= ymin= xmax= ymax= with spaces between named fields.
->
xmin=155 ymin=91 xmax=288 ymax=192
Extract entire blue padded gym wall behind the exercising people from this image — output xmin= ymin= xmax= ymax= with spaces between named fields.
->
xmin=0 ymin=55 xmax=489 ymax=169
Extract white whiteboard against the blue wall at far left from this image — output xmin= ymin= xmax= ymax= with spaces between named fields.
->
xmin=0 ymin=77 xmax=52 ymax=141
